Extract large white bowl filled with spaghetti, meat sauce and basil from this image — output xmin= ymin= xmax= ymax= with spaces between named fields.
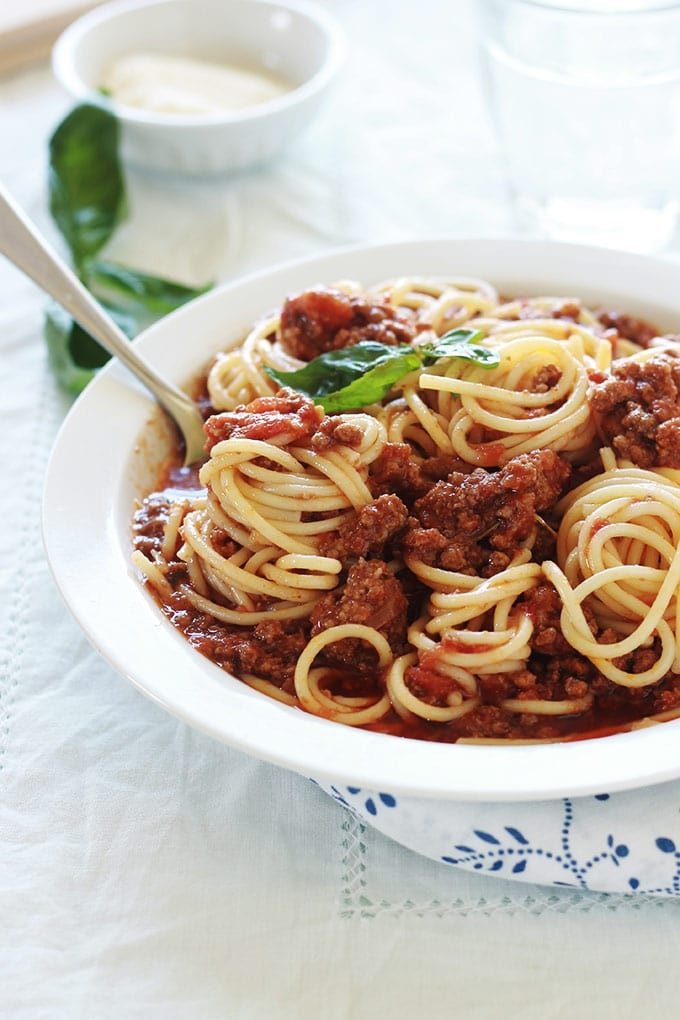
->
xmin=44 ymin=234 xmax=680 ymax=824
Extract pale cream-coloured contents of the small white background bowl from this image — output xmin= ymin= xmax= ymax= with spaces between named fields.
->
xmin=99 ymin=53 xmax=292 ymax=115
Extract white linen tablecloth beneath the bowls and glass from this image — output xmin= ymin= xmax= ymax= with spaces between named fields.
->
xmin=0 ymin=0 xmax=680 ymax=1020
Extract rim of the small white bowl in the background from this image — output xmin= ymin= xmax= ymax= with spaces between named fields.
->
xmin=52 ymin=0 xmax=348 ymax=132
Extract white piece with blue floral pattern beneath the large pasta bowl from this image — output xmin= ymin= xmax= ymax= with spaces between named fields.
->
xmin=315 ymin=780 xmax=680 ymax=897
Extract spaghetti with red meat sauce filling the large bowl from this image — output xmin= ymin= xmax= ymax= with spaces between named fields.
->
xmin=134 ymin=277 xmax=680 ymax=743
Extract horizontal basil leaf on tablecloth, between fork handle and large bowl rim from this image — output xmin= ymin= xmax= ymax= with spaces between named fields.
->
xmin=87 ymin=259 xmax=213 ymax=315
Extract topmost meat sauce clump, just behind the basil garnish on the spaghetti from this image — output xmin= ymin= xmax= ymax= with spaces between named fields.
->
xmin=279 ymin=287 xmax=418 ymax=361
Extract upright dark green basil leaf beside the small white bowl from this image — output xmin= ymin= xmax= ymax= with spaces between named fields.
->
xmin=48 ymin=105 xmax=125 ymax=273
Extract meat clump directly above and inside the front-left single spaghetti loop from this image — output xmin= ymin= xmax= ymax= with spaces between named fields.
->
xmin=311 ymin=559 xmax=408 ymax=671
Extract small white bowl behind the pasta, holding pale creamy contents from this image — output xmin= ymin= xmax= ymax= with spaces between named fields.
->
xmin=52 ymin=0 xmax=346 ymax=175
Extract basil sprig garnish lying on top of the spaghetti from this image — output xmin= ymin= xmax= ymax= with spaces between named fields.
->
xmin=265 ymin=329 xmax=500 ymax=414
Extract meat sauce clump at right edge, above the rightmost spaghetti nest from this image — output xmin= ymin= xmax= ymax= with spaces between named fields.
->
xmin=588 ymin=353 xmax=680 ymax=468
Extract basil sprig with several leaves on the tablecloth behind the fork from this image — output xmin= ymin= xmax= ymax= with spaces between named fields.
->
xmin=45 ymin=105 xmax=210 ymax=393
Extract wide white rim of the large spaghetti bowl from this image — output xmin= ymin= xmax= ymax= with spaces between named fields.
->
xmin=43 ymin=238 xmax=680 ymax=802
